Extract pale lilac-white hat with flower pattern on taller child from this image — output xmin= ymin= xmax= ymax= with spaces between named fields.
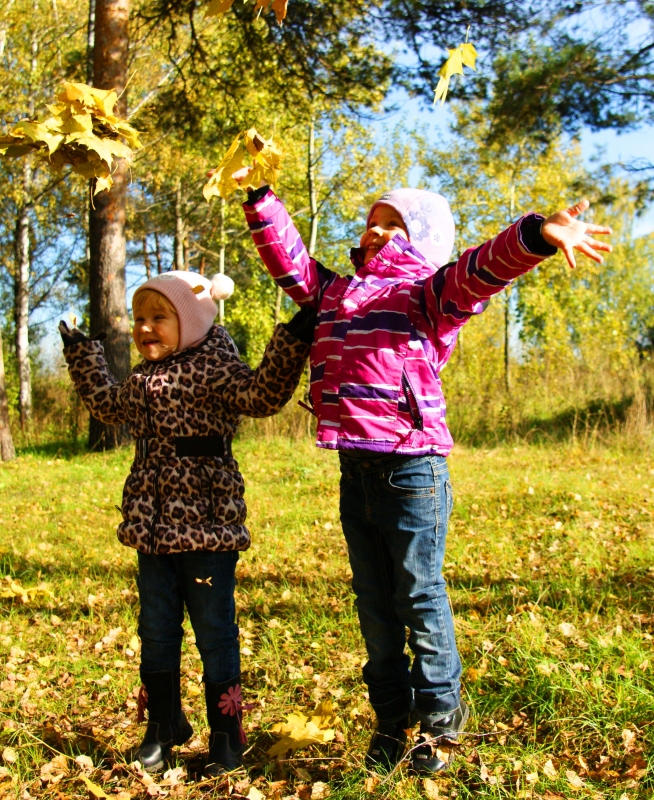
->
xmin=368 ymin=189 xmax=454 ymax=267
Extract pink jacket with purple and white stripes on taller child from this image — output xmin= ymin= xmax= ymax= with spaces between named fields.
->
xmin=243 ymin=185 xmax=556 ymax=455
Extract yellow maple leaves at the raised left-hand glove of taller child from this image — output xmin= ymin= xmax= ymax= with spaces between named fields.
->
xmin=202 ymin=128 xmax=283 ymax=200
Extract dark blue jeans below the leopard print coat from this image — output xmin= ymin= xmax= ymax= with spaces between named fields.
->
xmin=137 ymin=550 xmax=241 ymax=683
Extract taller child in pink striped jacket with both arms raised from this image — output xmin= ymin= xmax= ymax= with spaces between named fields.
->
xmin=234 ymin=171 xmax=611 ymax=774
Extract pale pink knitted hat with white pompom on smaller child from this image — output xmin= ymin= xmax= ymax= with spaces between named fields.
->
xmin=134 ymin=270 xmax=234 ymax=350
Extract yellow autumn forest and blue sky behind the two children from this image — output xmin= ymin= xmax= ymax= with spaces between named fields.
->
xmin=0 ymin=0 xmax=654 ymax=448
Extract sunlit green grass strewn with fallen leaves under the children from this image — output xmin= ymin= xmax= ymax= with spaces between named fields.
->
xmin=0 ymin=435 xmax=654 ymax=800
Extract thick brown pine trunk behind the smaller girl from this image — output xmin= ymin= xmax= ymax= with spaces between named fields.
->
xmin=89 ymin=0 xmax=130 ymax=450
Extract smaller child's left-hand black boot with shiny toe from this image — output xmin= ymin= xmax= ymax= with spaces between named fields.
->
xmin=134 ymin=670 xmax=193 ymax=772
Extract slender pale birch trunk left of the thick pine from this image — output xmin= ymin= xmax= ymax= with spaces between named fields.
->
xmin=15 ymin=158 xmax=32 ymax=431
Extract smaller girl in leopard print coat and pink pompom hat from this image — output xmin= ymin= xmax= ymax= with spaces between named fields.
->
xmin=59 ymin=271 xmax=315 ymax=776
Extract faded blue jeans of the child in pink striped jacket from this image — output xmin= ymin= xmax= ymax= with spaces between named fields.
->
xmin=340 ymin=452 xmax=461 ymax=723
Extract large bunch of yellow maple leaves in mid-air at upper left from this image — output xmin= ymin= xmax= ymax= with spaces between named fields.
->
xmin=0 ymin=83 xmax=141 ymax=194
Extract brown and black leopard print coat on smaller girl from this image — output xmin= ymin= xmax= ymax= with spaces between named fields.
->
xmin=64 ymin=325 xmax=309 ymax=554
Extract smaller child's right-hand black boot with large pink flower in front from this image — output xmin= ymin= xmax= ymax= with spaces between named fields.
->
xmin=204 ymin=675 xmax=247 ymax=778
